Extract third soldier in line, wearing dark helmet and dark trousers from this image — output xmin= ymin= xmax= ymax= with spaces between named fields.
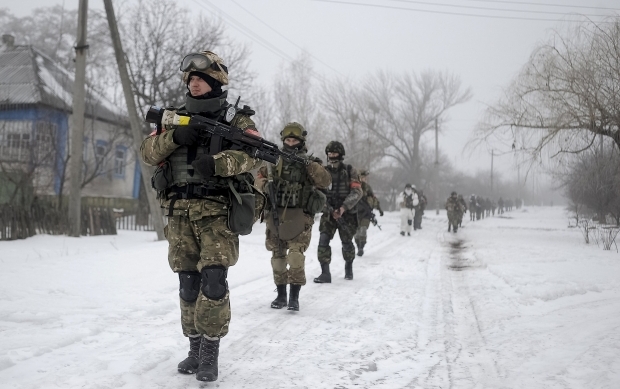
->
xmin=314 ymin=141 xmax=363 ymax=284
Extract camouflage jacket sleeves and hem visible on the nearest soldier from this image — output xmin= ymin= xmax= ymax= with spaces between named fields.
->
xmin=140 ymin=104 xmax=262 ymax=220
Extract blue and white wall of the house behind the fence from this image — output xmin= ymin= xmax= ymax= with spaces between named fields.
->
xmin=0 ymin=106 xmax=141 ymax=203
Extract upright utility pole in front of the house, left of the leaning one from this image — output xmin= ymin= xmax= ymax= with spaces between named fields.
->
xmin=68 ymin=0 xmax=88 ymax=237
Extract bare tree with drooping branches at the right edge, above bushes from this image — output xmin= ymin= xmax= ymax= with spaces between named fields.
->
xmin=475 ymin=17 xmax=620 ymax=159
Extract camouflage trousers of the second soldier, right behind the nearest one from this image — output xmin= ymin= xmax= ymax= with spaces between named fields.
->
xmin=265 ymin=214 xmax=314 ymax=285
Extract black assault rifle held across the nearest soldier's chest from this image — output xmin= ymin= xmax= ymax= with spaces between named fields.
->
xmin=145 ymin=106 xmax=312 ymax=165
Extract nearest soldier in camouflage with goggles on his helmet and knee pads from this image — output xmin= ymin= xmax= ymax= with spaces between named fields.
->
xmin=140 ymin=51 xmax=264 ymax=381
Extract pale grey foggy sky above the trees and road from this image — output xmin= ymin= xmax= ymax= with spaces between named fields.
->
xmin=0 ymin=0 xmax=620 ymax=178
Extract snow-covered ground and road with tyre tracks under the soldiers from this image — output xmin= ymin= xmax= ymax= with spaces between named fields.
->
xmin=0 ymin=207 xmax=620 ymax=389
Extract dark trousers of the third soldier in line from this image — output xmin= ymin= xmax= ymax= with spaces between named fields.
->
xmin=317 ymin=212 xmax=357 ymax=264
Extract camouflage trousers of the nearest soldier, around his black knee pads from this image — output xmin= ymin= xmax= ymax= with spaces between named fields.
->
xmin=164 ymin=216 xmax=239 ymax=338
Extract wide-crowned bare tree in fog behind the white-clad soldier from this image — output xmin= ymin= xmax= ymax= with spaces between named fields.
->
xmin=363 ymin=70 xmax=471 ymax=179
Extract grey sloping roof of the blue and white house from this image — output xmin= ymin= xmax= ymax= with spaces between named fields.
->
xmin=0 ymin=45 xmax=127 ymax=123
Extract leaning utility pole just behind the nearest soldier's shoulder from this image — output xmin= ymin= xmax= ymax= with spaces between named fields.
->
xmin=103 ymin=0 xmax=165 ymax=240
